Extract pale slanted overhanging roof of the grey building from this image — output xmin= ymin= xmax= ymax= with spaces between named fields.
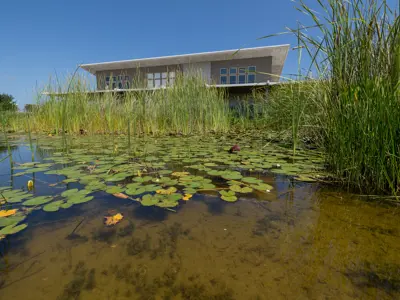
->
xmin=80 ymin=45 xmax=289 ymax=75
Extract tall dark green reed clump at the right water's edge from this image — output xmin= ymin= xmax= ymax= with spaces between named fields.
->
xmin=269 ymin=0 xmax=400 ymax=194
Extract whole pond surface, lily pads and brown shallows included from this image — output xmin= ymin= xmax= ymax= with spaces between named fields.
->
xmin=0 ymin=136 xmax=400 ymax=300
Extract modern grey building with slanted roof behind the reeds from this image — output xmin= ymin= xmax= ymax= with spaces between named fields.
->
xmin=81 ymin=45 xmax=289 ymax=92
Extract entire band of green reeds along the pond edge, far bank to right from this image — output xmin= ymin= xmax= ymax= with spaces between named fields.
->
xmin=1 ymin=0 xmax=400 ymax=200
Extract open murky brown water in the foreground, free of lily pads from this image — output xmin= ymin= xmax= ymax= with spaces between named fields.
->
xmin=0 ymin=137 xmax=400 ymax=300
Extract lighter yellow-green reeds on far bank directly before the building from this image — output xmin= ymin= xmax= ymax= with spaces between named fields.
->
xmin=9 ymin=76 xmax=231 ymax=135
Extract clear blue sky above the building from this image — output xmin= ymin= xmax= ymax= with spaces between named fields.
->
xmin=0 ymin=0 xmax=397 ymax=108
